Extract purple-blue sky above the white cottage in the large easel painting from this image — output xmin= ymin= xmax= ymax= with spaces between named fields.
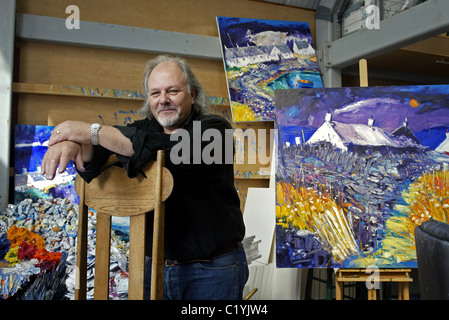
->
xmin=275 ymin=85 xmax=449 ymax=132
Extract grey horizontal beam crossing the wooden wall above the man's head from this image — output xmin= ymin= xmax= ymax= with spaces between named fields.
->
xmin=16 ymin=13 xmax=222 ymax=60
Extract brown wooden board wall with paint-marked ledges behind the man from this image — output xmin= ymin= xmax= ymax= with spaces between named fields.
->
xmin=14 ymin=0 xmax=315 ymax=210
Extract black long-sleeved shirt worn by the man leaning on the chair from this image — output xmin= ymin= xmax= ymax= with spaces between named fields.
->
xmin=79 ymin=111 xmax=245 ymax=261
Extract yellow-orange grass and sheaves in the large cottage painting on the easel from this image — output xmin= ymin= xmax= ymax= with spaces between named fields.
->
xmin=276 ymin=170 xmax=449 ymax=268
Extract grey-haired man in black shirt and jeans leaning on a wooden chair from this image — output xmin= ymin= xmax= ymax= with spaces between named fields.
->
xmin=42 ymin=56 xmax=248 ymax=300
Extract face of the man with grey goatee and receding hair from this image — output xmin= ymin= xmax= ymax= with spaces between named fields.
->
xmin=148 ymin=61 xmax=195 ymax=133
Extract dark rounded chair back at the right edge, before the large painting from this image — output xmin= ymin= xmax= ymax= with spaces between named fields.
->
xmin=415 ymin=219 xmax=449 ymax=300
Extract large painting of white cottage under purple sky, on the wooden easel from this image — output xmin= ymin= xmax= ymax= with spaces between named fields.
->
xmin=275 ymin=85 xmax=449 ymax=268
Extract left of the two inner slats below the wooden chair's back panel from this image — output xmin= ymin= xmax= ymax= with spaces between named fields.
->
xmin=94 ymin=212 xmax=111 ymax=300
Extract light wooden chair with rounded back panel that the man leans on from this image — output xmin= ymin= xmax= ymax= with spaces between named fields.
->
xmin=75 ymin=151 xmax=173 ymax=300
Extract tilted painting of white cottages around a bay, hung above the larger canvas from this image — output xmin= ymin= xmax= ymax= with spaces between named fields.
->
xmin=217 ymin=17 xmax=323 ymax=122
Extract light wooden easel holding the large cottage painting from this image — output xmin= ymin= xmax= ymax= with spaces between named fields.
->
xmin=335 ymin=59 xmax=413 ymax=300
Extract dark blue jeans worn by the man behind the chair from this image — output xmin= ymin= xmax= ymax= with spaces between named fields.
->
xmin=145 ymin=245 xmax=249 ymax=300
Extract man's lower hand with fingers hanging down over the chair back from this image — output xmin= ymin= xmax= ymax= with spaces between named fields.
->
xmin=41 ymin=141 xmax=84 ymax=180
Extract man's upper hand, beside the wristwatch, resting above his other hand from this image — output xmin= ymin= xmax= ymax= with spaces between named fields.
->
xmin=48 ymin=121 xmax=92 ymax=146
